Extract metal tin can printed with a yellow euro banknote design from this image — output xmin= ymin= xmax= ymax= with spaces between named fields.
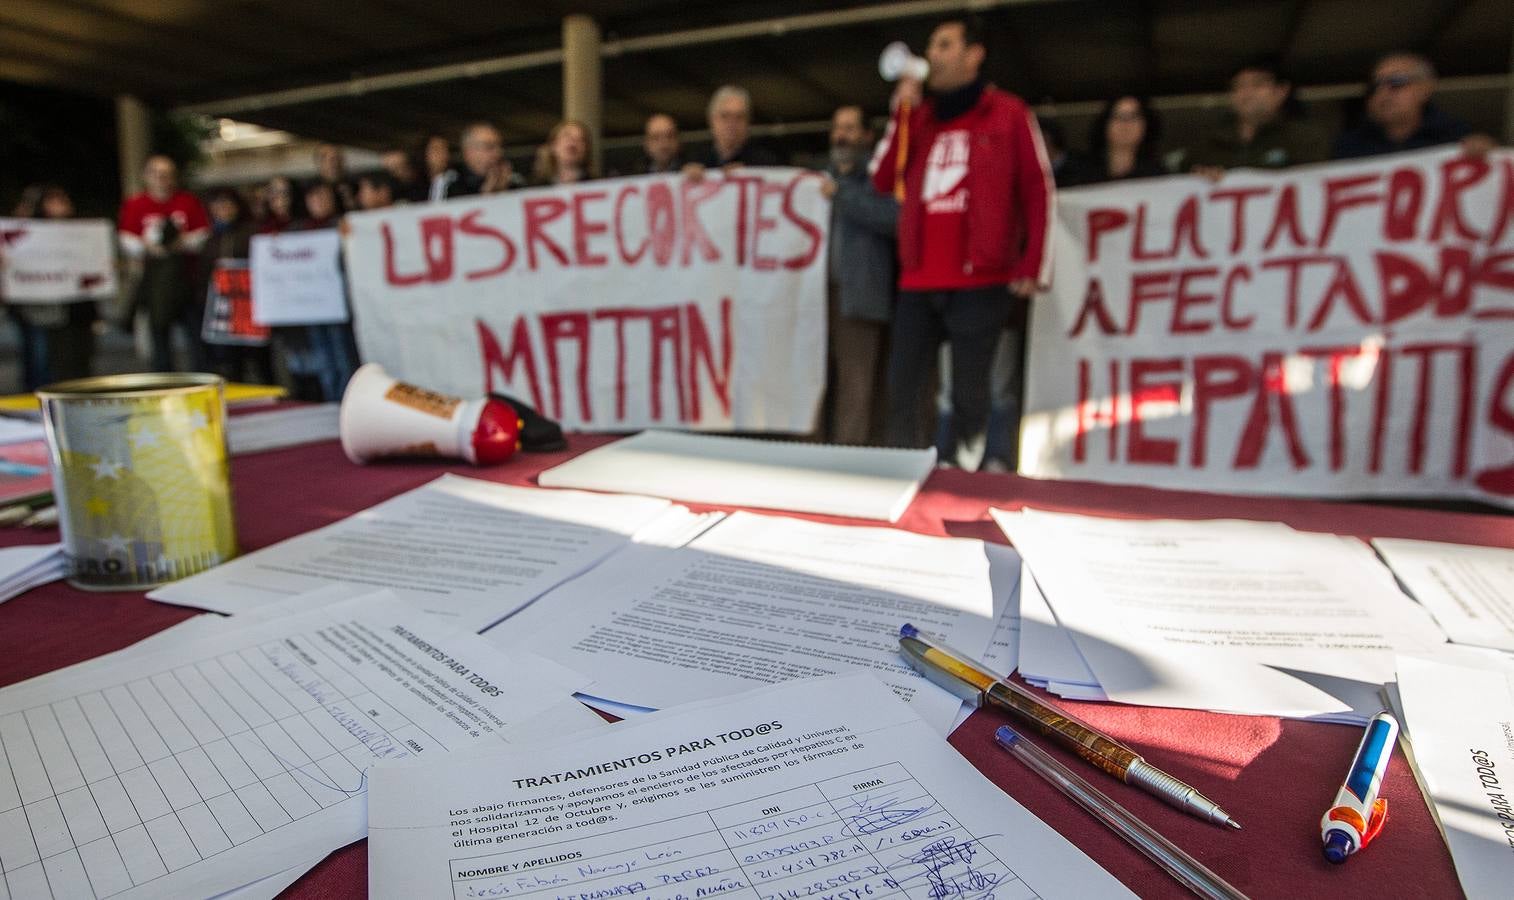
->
xmin=36 ymin=373 xmax=236 ymax=591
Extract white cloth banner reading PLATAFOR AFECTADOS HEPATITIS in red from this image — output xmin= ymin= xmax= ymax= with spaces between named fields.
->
xmin=1020 ymin=150 xmax=1514 ymax=506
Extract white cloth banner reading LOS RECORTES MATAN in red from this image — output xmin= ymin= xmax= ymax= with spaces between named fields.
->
xmin=347 ymin=168 xmax=830 ymax=432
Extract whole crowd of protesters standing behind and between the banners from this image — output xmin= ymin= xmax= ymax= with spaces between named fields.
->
xmin=8 ymin=17 xmax=1493 ymax=468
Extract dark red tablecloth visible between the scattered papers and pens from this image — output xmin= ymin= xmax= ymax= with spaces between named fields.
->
xmin=0 ymin=438 xmax=1514 ymax=897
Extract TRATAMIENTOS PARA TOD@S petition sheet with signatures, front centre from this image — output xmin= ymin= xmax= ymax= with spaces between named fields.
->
xmin=368 ymin=673 xmax=1131 ymax=900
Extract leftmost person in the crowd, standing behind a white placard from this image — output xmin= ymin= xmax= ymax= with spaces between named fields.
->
xmin=11 ymin=185 xmax=95 ymax=384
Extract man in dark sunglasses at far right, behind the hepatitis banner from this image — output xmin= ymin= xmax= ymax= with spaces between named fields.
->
xmin=1334 ymin=53 xmax=1494 ymax=159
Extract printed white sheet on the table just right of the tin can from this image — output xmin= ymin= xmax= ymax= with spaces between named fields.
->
xmin=148 ymin=476 xmax=671 ymax=632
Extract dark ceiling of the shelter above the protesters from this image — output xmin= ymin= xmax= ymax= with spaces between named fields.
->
xmin=0 ymin=0 xmax=1514 ymax=147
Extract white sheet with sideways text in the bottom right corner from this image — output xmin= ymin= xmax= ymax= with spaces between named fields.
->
xmin=1397 ymin=656 xmax=1514 ymax=897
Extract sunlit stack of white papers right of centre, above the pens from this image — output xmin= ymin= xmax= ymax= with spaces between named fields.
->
xmin=993 ymin=509 xmax=1444 ymax=723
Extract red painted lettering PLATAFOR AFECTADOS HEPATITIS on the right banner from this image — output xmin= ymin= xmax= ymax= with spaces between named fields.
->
xmin=1047 ymin=150 xmax=1514 ymax=495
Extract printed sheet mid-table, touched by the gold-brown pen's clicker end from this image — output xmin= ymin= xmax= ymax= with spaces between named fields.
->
xmin=488 ymin=512 xmax=1008 ymax=733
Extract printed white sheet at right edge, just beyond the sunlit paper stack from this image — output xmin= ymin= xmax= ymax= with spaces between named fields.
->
xmin=1372 ymin=538 xmax=1514 ymax=650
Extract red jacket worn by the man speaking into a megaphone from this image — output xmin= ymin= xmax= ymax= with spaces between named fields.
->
xmin=872 ymin=85 xmax=1055 ymax=289
